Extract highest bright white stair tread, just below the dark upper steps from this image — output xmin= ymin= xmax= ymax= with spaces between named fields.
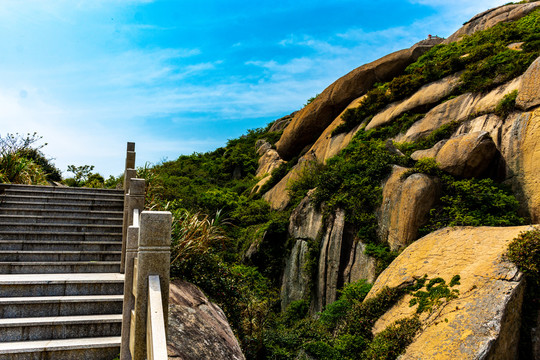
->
xmin=0 ymin=273 xmax=124 ymax=285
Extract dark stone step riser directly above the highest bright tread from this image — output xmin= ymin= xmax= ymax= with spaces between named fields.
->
xmin=0 ymin=261 xmax=120 ymax=274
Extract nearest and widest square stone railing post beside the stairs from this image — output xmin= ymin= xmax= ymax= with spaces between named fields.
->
xmin=130 ymin=211 xmax=172 ymax=360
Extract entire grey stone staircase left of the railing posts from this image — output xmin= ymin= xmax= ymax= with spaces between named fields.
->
xmin=0 ymin=185 xmax=124 ymax=360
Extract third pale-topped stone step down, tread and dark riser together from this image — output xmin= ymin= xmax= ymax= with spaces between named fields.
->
xmin=0 ymin=314 xmax=122 ymax=342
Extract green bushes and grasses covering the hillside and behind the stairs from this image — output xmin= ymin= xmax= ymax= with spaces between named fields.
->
xmin=0 ymin=3 xmax=540 ymax=360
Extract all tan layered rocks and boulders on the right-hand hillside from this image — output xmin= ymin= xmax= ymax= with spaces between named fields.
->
xmin=261 ymin=2 xmax=540 ymax=359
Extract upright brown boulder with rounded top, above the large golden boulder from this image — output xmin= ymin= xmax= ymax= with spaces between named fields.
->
xmin=379 ymin=166 xmax=440 ymax=250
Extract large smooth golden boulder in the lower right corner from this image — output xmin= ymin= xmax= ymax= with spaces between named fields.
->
xmin=368 ymin=226 xmax=530 ymax=360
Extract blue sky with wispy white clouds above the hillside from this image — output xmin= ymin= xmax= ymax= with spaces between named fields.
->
xmin=0 ymin=0 xmax=507 ymax=176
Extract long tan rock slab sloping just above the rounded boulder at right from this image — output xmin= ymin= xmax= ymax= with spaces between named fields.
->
xmin=396 ymin=76 xmax=522 ymax=142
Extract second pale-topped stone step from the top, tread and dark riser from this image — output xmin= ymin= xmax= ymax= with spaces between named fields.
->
xmin=0 ymin=295 xmax=124 ymax=319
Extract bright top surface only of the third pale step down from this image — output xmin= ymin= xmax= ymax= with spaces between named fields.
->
xmin=0 ymin=314 xmax=122 ymax=328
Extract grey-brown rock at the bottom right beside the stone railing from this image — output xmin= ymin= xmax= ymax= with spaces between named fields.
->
xmin=167 ymin=280 xmax=245 ymax=360
